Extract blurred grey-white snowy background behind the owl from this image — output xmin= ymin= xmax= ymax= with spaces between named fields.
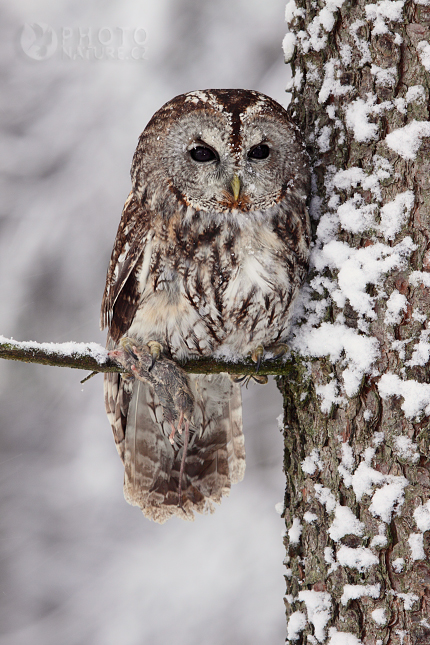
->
xmin=0 ymin=0 xmax=288 ymax=645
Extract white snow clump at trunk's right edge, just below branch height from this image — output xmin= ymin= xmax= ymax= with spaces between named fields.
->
xmin=378 ymin=372 xmax=430 ymax=419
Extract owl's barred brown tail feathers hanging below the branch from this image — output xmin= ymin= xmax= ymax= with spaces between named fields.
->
xmin=120 ymin=374 xmax=245 ymax=523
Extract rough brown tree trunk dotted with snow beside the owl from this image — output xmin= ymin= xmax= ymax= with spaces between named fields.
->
xmin=278 ymin=0 xmax=430 ymax=645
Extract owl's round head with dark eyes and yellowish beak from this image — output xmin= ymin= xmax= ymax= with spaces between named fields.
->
xmin=131 ymin=89 xmax=309 ymax=214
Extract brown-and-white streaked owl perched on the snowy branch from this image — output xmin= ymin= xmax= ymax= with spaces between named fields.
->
xmin=101 ymin=89 xmax=310 ymax=523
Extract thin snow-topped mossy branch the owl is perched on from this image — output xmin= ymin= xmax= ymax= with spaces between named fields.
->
xmin=0 ymin=336 xmax=293 ymax=376
